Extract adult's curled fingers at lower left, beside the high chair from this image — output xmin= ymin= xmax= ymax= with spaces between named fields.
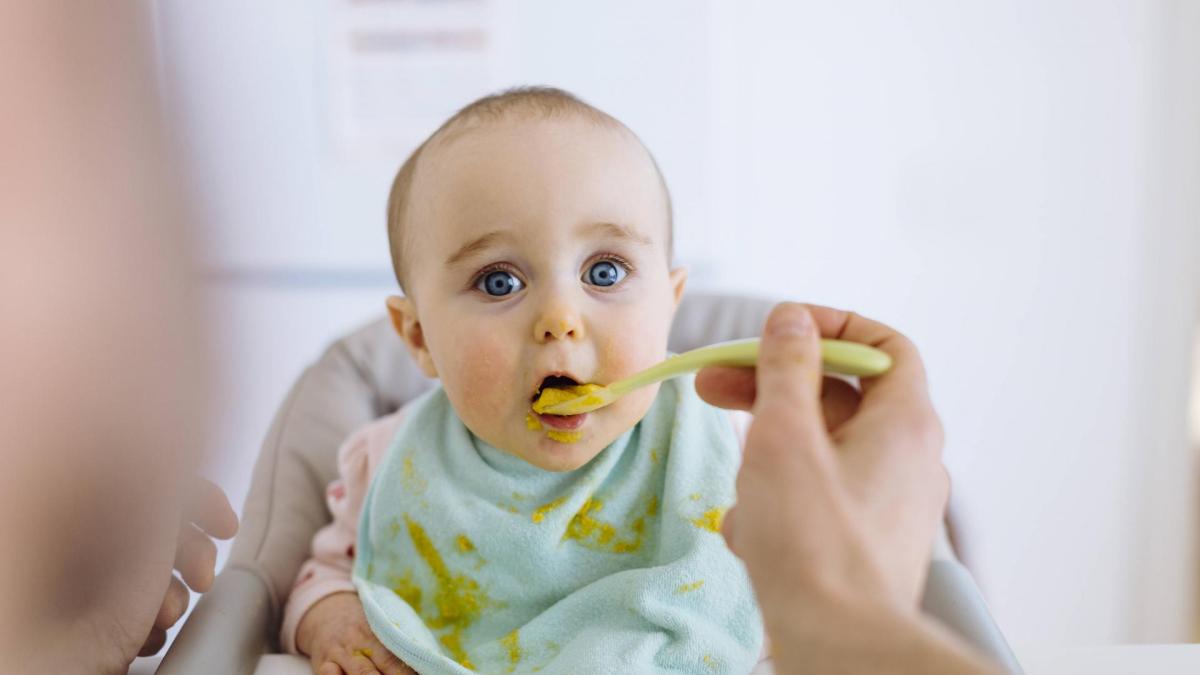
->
xmin=138 ymin=477 xmax=238 ymax=656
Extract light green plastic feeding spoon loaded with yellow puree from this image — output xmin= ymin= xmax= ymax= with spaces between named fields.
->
xmin=534 ymin=338 xmax=892 ymax=414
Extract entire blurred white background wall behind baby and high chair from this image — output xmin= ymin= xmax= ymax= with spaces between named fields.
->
xmin=152 ymin=0 xmax=1200 ymax=650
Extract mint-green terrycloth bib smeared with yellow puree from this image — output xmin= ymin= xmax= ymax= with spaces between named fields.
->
xmin=354 ymin=378 xmax=762 ymax=674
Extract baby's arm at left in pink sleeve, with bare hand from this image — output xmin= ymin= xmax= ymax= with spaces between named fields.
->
xmin=280 ymin=413 xmax=410 ymax=673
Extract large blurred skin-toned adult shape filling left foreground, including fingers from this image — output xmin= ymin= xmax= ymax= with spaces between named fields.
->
xmin=0 ymin=0 xmax=236 ymax=673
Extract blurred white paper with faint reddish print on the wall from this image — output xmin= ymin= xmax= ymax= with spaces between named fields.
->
xmin=329 ymin=0 xmax=496 ymax=157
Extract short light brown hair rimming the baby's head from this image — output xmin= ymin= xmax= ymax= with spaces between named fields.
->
xmin=388 ymin=86 xmax=674 ymax=289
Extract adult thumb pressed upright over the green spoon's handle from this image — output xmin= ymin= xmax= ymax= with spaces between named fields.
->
xmin=754 ymin=303 xmax=824 ymax=432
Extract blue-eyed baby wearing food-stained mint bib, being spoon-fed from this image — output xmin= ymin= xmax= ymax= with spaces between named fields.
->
xmin=281 ymin=88 xmax=763 ymax=674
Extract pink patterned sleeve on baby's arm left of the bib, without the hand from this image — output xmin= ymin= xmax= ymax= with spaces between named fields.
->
xmin=280 ymin=408 xmax=403 ymax=653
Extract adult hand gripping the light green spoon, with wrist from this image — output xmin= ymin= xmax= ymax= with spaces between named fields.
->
xmin=696 ymin=303 xmax=983 ymax=673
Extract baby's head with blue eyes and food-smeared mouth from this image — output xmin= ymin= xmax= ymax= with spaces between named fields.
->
xmin=388 ymin=89 xmax=686 ymax=471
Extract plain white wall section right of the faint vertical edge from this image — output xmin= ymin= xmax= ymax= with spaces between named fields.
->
xmin=712 ymin=1 xmax=1200 ymax=643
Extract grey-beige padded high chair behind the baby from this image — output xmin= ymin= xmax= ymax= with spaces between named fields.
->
xmin=158 ymin=294 xmax=1020 ymax=675
